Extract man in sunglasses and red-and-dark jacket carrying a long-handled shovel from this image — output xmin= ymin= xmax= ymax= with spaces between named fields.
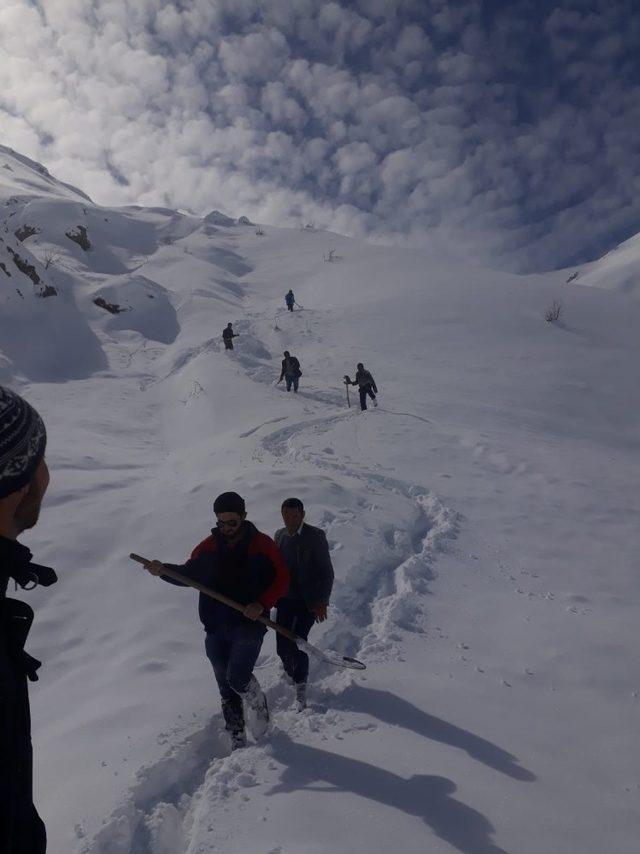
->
xmin=146 ymin=492 xmax=289 ymax=748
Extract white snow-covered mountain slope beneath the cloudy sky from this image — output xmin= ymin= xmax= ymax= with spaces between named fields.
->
xmin=0 ymin=148 xmax=640 ymax=854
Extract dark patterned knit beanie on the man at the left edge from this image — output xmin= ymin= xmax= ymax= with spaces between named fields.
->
xmin=0 ymin=386 xmax=47 ymax=498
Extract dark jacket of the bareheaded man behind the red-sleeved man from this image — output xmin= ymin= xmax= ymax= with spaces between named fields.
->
xmin=274 ymin=522 xmax=333 ymax=608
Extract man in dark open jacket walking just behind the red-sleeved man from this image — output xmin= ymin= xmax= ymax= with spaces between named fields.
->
xmin=274 ymin=498 xmax=333 ymax=711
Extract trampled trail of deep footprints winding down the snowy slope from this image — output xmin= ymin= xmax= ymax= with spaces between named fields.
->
xmin=79 ymin=344 xmax=458 ymax=854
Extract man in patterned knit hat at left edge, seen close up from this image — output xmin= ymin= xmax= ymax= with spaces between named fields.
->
xmin=0 ymin=386 xmax=57 ymax=854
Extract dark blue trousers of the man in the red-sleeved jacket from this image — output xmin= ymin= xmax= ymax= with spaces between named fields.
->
xmin=204 ymin=619 xmax=267 ymax=732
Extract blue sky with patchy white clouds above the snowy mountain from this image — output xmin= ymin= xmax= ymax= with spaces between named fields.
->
xmin=0 ymin=0 xmax=640 ymax=270
